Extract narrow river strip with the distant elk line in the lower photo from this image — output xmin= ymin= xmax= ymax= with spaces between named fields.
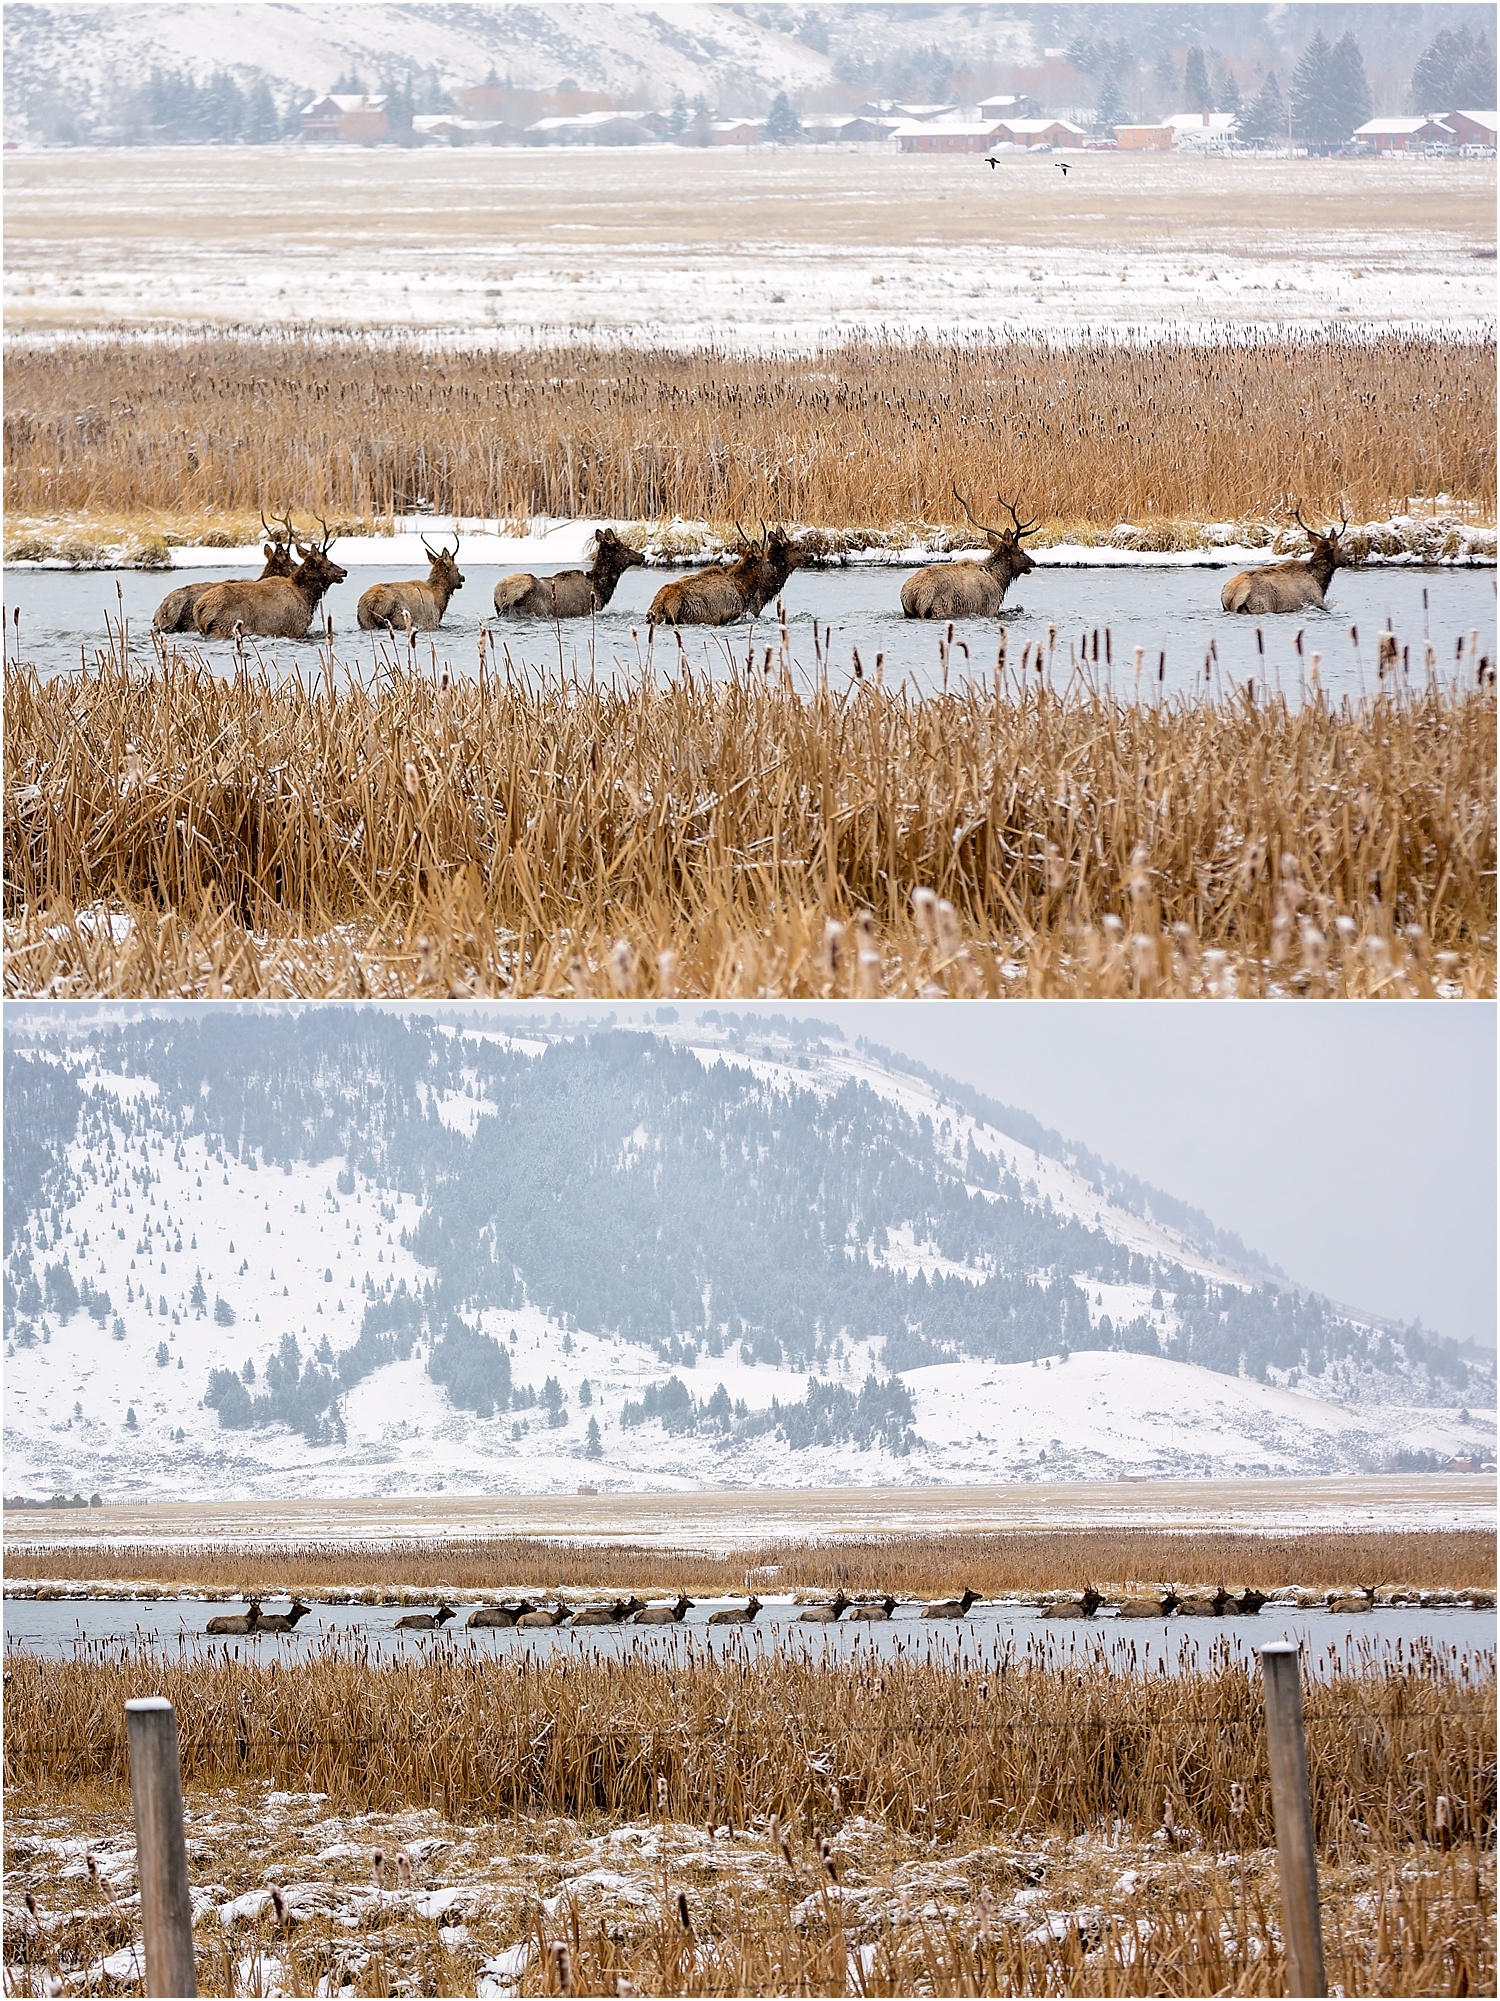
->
xmin=4 ymin=1595 xmax=1496 ymax=1673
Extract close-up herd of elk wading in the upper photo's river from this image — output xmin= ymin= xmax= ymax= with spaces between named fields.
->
xmin=152 ymin=500 xmax=1350 ymax=638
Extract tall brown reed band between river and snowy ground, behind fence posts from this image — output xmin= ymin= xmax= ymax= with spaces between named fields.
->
xmin=4 ymin=1629 xmax=1496 ymax=1847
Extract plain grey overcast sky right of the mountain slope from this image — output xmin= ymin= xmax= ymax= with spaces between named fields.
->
xmin=548 ymin=1001 xmax=1496 ymax=1347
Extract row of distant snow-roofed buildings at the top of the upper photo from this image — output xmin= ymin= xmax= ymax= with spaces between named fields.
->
xmin=302 ymin=90 xmax=1496 ymax=154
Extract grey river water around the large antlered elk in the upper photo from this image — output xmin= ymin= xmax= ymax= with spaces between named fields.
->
xmin=4 ymin=562 xmax=1496 ymax=702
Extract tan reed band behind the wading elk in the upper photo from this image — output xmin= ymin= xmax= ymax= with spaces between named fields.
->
xmin=4 ymin=330 xmax=1496 ymax=526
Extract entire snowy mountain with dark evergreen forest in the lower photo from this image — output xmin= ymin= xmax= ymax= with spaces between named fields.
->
xmin=4 ymin=1007 xmax=1494 ymax=1499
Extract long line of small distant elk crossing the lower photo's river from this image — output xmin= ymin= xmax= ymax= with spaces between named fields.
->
xmin=204 ymin=1585 xmax=1376 ymax=1639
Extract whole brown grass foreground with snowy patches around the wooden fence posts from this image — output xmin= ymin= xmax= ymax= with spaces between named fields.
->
xmin=4 ymin=1641 xmax=1496 ymax=1995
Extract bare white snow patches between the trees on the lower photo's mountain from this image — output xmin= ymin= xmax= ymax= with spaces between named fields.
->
xmin=4 ymin=1043 xmax=1494 ymax=1501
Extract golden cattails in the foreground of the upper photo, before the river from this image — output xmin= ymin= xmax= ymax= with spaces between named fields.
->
xmin=4 ymin=656 xmax=1496 ymax=996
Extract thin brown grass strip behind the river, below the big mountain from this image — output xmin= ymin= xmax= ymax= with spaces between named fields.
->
xmin=6 ymin=1517 xmax=1496 ymax=1601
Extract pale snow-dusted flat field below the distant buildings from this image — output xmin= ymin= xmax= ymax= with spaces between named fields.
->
xmin=4 ymin=146 xmax=1494 ymax=350
